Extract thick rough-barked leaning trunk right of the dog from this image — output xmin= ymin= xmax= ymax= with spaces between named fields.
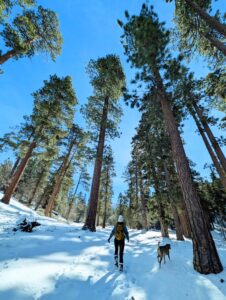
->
xmin=153 ymin=69 xmax=223 ymax=274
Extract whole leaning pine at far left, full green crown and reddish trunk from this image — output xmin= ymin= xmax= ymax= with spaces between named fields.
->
xmin=1 ymin=75 xmax=77 ymax=204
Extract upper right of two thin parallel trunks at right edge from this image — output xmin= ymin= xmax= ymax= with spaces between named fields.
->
xmin=193 ymin=102 xmax=226 ymax=173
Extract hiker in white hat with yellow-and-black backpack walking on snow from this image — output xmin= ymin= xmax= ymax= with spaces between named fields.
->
xmin=108 ymin=215 xmax=129 ymax=271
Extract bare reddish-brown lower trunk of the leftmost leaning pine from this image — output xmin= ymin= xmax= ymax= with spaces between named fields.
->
xmin=1 ymin=141 xmax=37 ymax=204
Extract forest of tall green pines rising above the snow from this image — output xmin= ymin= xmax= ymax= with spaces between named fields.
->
xmin=0 ymin=0 xmax=226 ymax=274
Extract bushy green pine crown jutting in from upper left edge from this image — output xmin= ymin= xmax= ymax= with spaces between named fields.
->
xmin=0 ymin=6 xmax=63 ymax=65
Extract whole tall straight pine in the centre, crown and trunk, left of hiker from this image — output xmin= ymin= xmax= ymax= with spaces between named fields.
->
xmin=83 ymin=55 xmax=125 ymax=231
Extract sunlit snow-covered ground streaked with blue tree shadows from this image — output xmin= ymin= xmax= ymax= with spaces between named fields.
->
xmin=0 ymin=196 xmax=226 ymax=300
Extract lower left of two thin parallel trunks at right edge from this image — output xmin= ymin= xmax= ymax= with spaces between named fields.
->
xmin=191 ymin=112 xmax=226 ymax=190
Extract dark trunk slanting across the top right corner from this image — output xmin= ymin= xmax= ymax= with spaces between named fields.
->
xmin=184 ymin=0 xmax=226 ymax=37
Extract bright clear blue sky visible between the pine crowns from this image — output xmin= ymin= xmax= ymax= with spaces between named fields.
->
xmin=0 ymin=0 xmax=224 ymax=204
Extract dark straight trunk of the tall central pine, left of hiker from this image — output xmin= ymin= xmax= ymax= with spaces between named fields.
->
xmin=83 ymin=97 xmax=109 ymax=231
